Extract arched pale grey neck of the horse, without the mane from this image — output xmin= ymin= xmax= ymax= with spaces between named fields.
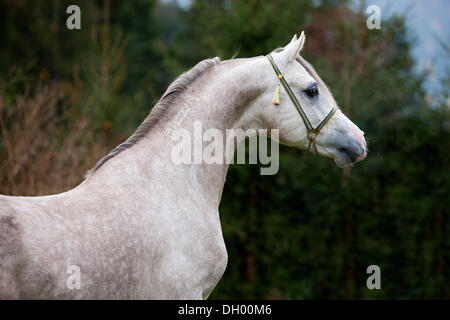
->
xmin=87 ymin=58 xmax=267 ymax=207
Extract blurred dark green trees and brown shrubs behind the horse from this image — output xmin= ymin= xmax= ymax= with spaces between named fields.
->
xmin=0 ymin=0 xmax=450 ymax=299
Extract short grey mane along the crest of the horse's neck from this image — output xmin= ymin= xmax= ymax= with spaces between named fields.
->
xmin=86 ymin=57 xmax=220 ymax=178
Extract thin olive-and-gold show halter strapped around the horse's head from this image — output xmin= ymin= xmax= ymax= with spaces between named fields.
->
xmin=267 ymin=54 xmax=337 ymax=153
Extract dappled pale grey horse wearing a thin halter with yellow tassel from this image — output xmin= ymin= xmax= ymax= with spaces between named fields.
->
xmin=0 ymin=32 xmax=366 ymax=299
